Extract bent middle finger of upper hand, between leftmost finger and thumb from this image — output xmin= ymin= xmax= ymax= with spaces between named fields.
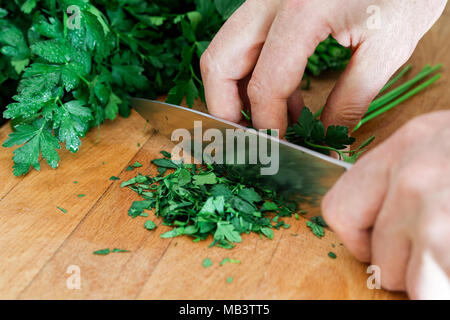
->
xmin=248 ymin=1 xmax=329 ymax=136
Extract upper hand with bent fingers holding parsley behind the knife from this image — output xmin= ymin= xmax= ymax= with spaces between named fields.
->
xmin=201 ymin=0 xmax=447 ymax=136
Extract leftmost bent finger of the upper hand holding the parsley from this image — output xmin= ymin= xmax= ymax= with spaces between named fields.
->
xmin=200 ymin=0 xmax=278 ymax=122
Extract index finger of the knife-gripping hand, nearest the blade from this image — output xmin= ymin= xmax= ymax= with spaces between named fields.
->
xmin=322 ymin=129 xmax=402 ymax=262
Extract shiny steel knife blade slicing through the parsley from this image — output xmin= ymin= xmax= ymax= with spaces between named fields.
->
xmin=131 ymin=98 xmax=351 ymax=216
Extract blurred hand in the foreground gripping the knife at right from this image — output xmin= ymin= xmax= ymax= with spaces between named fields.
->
xmin=322 ymin=111 xmax=450 ymax=299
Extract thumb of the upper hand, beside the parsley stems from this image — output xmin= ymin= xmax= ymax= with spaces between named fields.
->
xmin=322 ymin=38 xmax=412 ymax=128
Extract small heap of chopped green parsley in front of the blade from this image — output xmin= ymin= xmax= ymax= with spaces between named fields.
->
xmin=121 ymin=152 xmax=302 ymax=249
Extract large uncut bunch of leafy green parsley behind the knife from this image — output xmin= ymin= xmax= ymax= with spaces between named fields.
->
xmin=0 ymin=0 xmax=350 ymax=176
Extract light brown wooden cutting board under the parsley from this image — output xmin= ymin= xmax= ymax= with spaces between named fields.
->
xmin=0 ymin=9 xmax=450 ymax=299
